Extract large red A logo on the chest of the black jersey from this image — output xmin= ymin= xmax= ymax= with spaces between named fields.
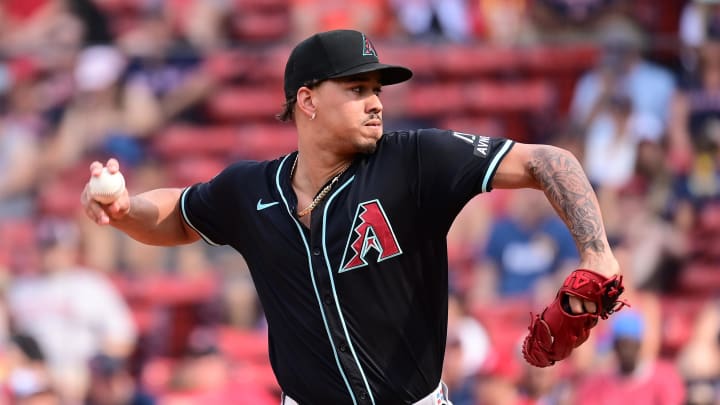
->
xmin=340 ymin=200 xmax=402 ymax=273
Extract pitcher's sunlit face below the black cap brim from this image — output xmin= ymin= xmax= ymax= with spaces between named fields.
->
xmin=313 ymin=72 xmax=383 ymax=153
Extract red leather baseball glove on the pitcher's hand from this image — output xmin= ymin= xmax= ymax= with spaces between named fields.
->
xmin=522 ymin=269 xmax=628 ymax=367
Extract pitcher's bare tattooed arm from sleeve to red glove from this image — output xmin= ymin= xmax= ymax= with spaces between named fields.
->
xmin=492 ymin=143 xmax=620 ymax=313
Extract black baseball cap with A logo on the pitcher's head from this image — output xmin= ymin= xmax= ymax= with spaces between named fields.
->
xmin=285 ymin=30 xmax=412 ymax=100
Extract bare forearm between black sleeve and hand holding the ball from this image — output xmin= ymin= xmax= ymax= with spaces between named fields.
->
xmin=110 ymin=188 xmax=199 ymax=246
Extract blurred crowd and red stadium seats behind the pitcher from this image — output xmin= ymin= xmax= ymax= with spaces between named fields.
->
xmin=0 ymin=0 xmax=720 ymax=405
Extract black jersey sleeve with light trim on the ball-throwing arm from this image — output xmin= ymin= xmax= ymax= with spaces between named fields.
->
xmin=180 ymin=162 xmax=248 ymax=246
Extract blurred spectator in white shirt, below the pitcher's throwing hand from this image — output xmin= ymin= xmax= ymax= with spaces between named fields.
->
xmin=7 ymin=218 xmax=136 ymax=402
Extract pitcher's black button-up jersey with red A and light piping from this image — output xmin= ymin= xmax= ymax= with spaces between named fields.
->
xmin=181 ymin=129 xmax=513 ymax=405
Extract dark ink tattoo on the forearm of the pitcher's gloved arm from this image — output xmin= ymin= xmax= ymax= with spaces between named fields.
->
xmin=529 ymin=147 xmax=605 ymax=253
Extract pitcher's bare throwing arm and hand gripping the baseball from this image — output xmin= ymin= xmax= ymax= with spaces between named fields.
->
xmin=80 ymin=159 xmax=200 ymax=246
